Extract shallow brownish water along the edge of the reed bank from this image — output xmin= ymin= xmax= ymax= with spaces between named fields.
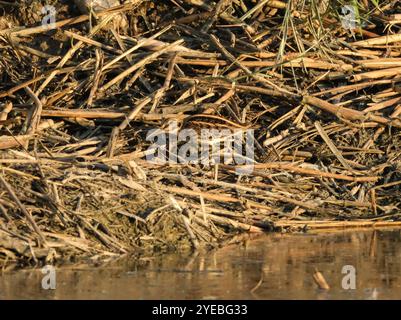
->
xmin=0 ymin=230 xmax=401 ymax=299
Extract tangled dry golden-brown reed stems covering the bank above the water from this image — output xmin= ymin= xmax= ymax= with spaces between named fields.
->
xmin=0 ymin=0 xmax=401 ymax=262
